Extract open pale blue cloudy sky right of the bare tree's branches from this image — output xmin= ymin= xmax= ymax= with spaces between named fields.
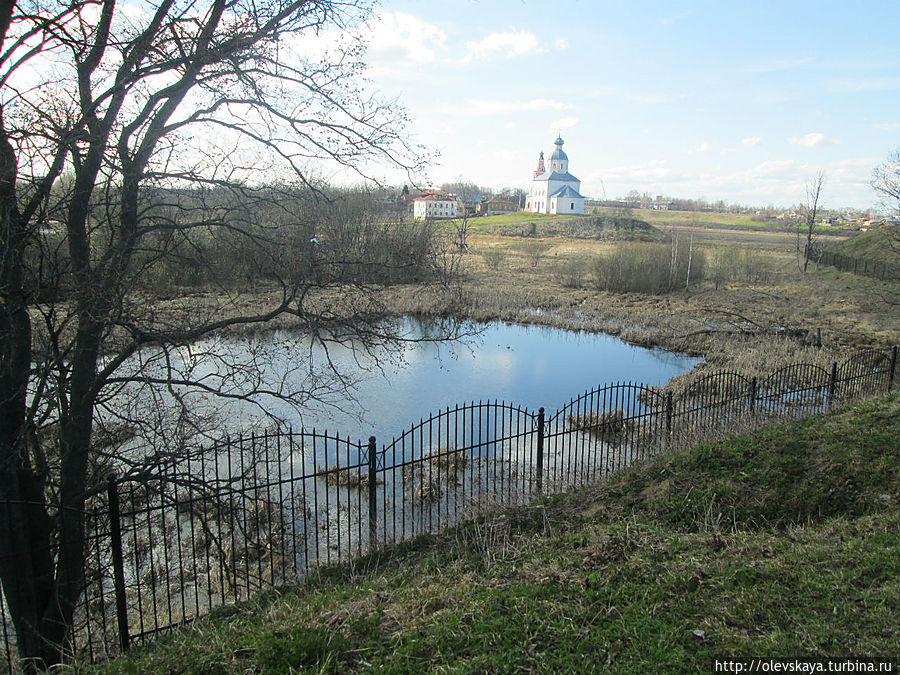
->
xmin=348 ymin=0 xmax=900 ymax=209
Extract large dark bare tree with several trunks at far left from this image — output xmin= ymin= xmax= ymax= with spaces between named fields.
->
xmin=0 ymin=0 xmax=458 ymax=670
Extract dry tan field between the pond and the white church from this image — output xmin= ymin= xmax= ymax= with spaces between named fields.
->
xmin=376 ymin=212 xmax=900 ymax=372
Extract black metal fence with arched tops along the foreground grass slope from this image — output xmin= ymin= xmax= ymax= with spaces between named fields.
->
xmin=0 ymin=347 xmax=897 ymax=670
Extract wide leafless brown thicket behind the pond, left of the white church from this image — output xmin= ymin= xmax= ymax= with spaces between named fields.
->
xmin=135 ymin=188 xmax=454 ymax=290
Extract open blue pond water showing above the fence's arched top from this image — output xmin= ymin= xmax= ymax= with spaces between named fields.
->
xmin=142 ymin=318 xmax=700 ymax=442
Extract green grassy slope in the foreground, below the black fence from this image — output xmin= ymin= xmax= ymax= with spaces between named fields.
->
xmin=86 ymin=395 xmax=900 ymax=673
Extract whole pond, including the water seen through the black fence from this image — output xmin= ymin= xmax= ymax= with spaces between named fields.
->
xmin=95 ymin=318 xmax=699 ymax=616
